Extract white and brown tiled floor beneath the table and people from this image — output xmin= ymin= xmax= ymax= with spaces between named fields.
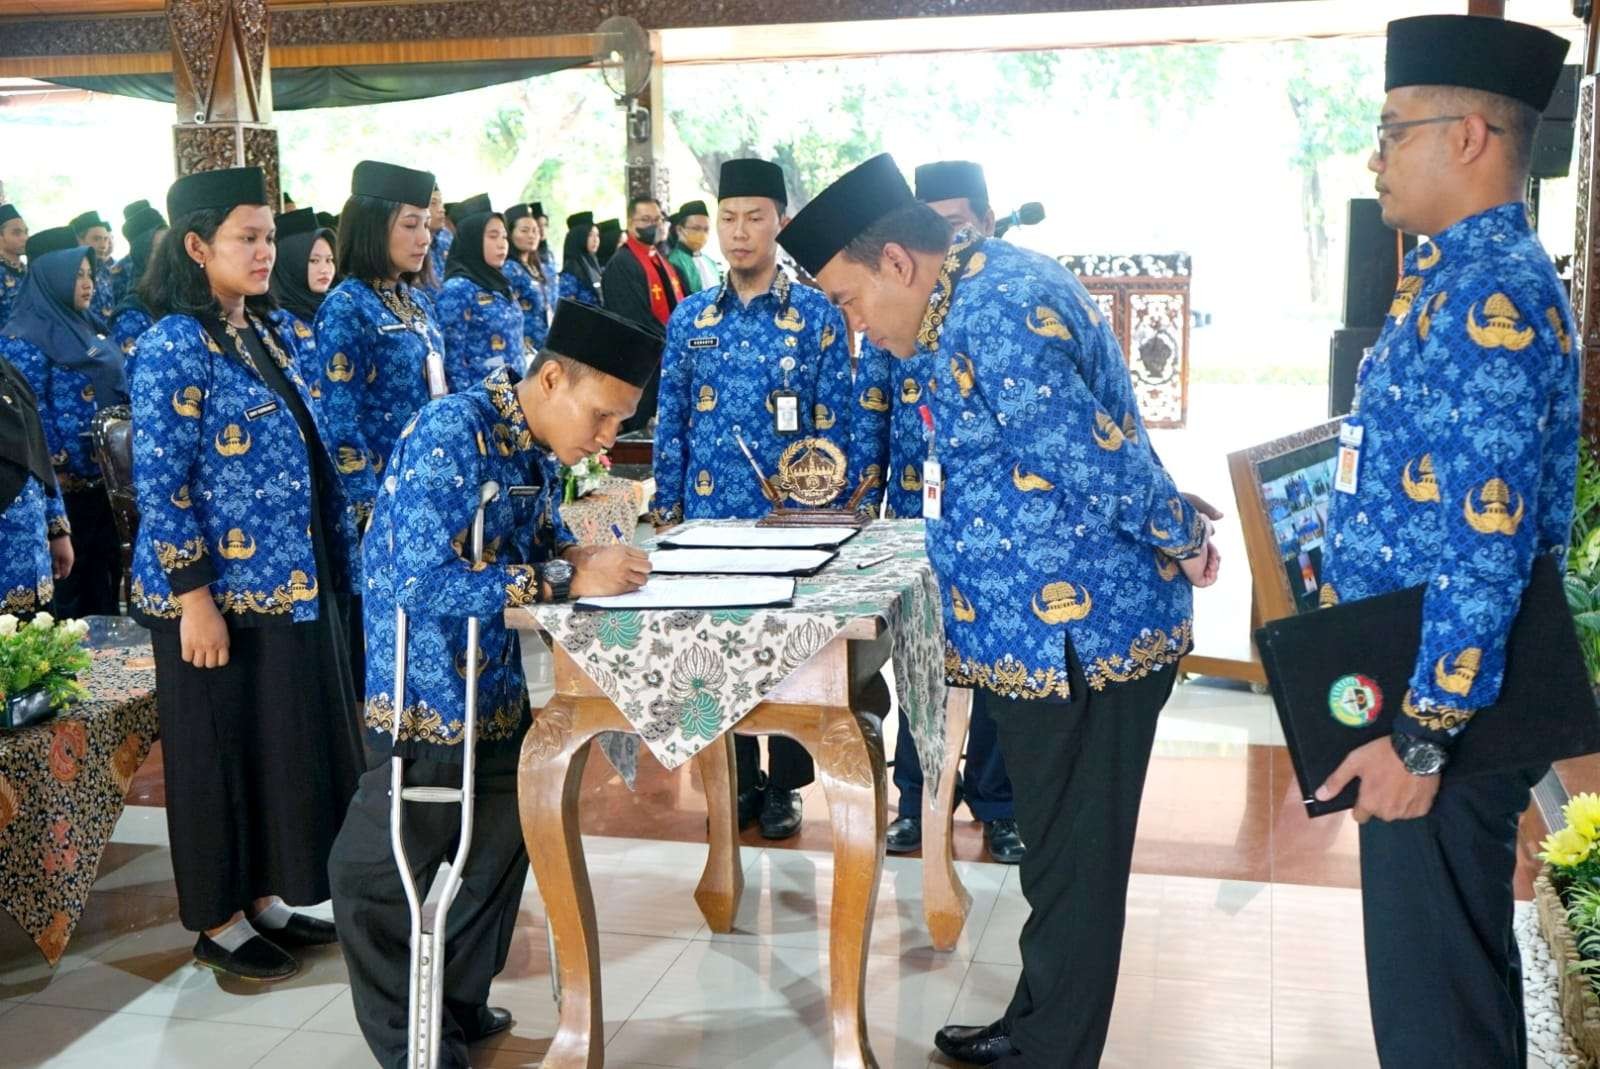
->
xmin=9 ymin=683 xmax=1561 ymax=1069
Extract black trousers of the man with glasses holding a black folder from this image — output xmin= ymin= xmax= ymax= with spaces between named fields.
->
xmin=1362 ymin=768 xmax=1546 ymax=1069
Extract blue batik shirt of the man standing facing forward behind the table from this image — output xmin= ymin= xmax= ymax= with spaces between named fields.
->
xmin=651 ymin=262 xmax=857 ymax=523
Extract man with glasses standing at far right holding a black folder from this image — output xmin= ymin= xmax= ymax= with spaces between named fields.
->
xmin=1317 ymin=14 xmax=1579 ymax=1069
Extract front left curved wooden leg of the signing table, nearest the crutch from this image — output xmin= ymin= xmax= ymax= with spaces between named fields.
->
xmin=517 ymin=695 xmax=610 ymax=1069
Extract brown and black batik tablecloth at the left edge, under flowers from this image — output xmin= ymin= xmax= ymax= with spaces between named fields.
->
xmin=0 ymin=633 xmax=157 ymax=965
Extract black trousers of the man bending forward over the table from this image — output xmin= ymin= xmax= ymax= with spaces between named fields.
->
xmin=989 ymin=648 xmax=1178 ymax=1069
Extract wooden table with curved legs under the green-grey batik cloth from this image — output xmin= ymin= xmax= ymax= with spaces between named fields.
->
xmin=507 ymin=521 xmax=971 ymax=1069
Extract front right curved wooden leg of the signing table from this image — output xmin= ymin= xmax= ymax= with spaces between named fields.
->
xmin=816 ymin=707 xmax=886 ymax=1069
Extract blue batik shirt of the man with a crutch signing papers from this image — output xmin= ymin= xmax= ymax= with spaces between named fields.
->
xmin=362 ymin=368 xmax=576 ymax=760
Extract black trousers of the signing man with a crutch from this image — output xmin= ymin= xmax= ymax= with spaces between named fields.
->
xmin=328 ymin=744 xmax=528 ymax=1069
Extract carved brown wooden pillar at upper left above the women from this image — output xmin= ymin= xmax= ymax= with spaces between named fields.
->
xmin=166 ymin=0 xmax=278 ymax=208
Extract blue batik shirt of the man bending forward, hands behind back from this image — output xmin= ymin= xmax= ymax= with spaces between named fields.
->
xmin=917 ymin=232 xmax=1205 ymax=699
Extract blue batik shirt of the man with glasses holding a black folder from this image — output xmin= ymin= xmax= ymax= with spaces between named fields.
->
xmin=1323 ymin=203 xmax=1579 ymax=741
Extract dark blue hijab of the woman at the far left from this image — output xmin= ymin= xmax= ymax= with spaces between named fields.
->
xmin=3 ymin=245 xmax=128 ymax=410
